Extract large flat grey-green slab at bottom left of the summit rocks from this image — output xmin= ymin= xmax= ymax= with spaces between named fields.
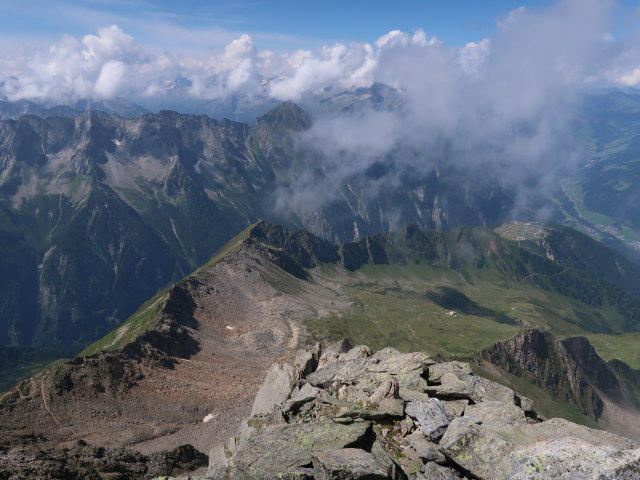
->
xmin=227 ymin=422 xmax=371 ymax=480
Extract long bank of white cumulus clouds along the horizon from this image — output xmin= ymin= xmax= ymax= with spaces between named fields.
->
xmin=0 ymin=0 xmax=640 ymax=109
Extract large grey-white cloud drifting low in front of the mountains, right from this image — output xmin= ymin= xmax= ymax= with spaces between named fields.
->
xmin=272 ymin=0 xmax=628 ymax=216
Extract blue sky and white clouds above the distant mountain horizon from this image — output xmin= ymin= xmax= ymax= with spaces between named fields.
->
xmin=0 ymin=0 xmax=640 ymax=104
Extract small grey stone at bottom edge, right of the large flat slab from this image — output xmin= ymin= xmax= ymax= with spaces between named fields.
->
xmin=313 ymin=448 xmax=389 ymax=480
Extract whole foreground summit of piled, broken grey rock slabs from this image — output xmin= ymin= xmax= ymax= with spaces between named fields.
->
xmin=202 ymin=340 xmax=640 ymax=480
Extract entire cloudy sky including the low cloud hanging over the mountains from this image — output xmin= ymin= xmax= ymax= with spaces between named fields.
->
xmin=0 ymin=0 xmax=640 ymax=220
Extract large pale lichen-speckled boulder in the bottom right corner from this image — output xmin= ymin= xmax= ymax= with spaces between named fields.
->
xmin=440 ymin=417 xmax=640 ymax=480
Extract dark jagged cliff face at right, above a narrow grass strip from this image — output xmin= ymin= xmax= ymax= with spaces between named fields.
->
xmin=481 ymin=330 xmax=640 ymax=435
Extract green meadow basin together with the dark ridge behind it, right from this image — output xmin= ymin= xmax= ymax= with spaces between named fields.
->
xmin=309 ymin=224 xmax=640 ymax=365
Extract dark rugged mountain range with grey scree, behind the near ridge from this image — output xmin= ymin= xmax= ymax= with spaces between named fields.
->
xmin=0 ymin=103 xmax=512 ymax=360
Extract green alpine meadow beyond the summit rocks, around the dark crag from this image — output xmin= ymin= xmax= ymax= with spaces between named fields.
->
xmin=307 ymin=256 xmax=640 ymax=427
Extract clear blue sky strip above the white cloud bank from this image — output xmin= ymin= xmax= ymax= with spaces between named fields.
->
xmin=0 ymin=0 xmax=638 ymax=50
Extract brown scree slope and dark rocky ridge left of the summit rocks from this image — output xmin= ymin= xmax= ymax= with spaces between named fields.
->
xmin=0 ymin=244 xmax=340 ymax=478
